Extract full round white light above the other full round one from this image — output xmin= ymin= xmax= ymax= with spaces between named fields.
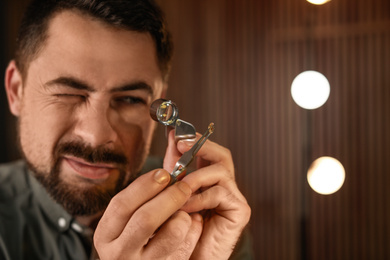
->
xmin=291 ymin=70 xmax=330 ymax=109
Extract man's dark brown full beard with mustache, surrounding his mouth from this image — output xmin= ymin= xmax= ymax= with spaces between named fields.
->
xmin=24 ymin=142 xmax=144 ymax=216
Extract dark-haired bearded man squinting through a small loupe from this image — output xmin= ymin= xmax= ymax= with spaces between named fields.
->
xmin=0 ymin=0 xmax=250 ymax=259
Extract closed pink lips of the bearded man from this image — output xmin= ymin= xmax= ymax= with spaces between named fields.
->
xmin=64 ymin=156 xmax=115 ymax=180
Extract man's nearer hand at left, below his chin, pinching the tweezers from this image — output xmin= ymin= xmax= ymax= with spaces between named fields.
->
xmin=94 ymin=169 xmax=202 ymax=260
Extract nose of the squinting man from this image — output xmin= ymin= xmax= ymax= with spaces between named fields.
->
xmin=74 ymin=101 xmax=118 ymax=147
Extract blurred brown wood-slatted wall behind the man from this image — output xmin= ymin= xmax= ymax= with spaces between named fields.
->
xmin=0 ymin=0 xmax=390 ymax=260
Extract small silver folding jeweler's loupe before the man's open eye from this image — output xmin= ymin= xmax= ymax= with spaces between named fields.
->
xmin=150 ymin=99 xmax=196 ymax=141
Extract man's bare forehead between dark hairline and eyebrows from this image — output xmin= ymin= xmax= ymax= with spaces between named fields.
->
xmin=27 ymin=11 xmax=161 ymax=91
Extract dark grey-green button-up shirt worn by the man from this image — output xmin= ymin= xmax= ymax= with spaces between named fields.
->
xmin=0 ymin=160 xmax=252 ymax=260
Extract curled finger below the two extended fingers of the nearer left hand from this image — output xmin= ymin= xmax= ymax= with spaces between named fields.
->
xmin=144 ymin=211 xmax=192 ymax=259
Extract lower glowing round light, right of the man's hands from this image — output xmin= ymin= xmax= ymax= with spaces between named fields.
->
xmin=307 ymin=157 xmax=345 ymax=195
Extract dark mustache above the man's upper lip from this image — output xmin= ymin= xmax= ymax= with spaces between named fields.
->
xmin=55 ymin=141 xmax=127 ymax=165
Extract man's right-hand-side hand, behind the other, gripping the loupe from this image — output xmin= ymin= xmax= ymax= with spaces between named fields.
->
xmin=164 ymin=133 xmax=251 ymax=259
